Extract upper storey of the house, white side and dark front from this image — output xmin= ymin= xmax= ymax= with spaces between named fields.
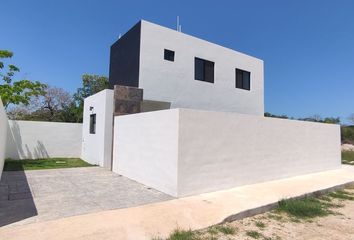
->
xmin=109 ymin=20 xmax=264 ymax=116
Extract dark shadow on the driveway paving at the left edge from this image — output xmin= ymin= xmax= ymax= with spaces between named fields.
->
xmin=0 ymin=166 xmax=37 ymax=227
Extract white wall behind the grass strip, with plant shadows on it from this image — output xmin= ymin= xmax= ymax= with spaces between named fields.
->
xmin=6 ymin=120 xmax=82 ymax=159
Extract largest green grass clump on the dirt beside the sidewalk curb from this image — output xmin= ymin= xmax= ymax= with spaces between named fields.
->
xmin=277 ymin=197 xmax=331 ymax=218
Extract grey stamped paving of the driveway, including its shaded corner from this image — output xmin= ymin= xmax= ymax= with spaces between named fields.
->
xmin=0 ymin=167 xmax=172 ymax=227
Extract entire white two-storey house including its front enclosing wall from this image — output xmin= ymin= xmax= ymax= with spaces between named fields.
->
xmin=82 ymin=21 xmax=341 ymax=197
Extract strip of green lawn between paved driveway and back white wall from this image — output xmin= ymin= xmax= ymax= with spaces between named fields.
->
xmin=4 ymin=158 xmax=93 ymax=171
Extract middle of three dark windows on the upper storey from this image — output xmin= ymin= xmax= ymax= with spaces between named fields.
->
xmin=194 ymin=58 xmax=214 ymax=83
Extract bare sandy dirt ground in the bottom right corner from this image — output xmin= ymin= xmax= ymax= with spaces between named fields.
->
xmin=198 ymin=189 xmax=354 ymax=240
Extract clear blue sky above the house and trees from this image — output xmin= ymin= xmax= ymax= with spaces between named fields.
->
xmin=0 ymin=0 xmax=354 ymax=122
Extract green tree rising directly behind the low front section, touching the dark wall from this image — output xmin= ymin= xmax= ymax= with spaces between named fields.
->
xmin=72 ymin=74 xmax=108 ymax=122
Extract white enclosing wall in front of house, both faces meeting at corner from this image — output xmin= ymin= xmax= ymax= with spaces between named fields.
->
xmin=113 ymin=109 xmax=341 ymax=197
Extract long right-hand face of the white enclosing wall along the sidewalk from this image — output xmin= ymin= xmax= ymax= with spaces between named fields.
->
xmin=178 ymin=109 xmax=341 ymax=196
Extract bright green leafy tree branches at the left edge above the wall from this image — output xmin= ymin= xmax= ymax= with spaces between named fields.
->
xmin=0 ymin=50 xmax=46 ymax=109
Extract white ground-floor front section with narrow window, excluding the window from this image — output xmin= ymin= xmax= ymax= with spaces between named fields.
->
xmin=81 ymin=89 xmax=114 ymax=169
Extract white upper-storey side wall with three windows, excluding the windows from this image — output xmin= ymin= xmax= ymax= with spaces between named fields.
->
xmin=139 ymin=21 xmax=264 ymax=116
